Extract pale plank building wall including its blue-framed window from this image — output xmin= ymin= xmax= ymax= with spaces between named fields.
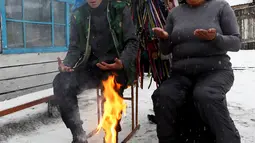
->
xmin=0 ymin=0 xmax=78 ymax=101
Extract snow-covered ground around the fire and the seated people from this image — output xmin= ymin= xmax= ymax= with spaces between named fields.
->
xmin=0 ymin=50 xmax=255 ymax=143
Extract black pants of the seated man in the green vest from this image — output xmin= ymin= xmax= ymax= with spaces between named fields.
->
xmin=53 ymin=67 xmax=127 ymax=130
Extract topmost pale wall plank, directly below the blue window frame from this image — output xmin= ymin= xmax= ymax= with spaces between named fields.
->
xmin=0 ymin=52 xmax=66 ymax=68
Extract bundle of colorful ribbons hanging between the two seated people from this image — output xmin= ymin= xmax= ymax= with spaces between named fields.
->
xmin=129 ymin=0 xmax=177 ymax=87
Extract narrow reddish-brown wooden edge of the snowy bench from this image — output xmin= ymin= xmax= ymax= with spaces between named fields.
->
xmin=0 ymin=95 xmax=53 ymax=117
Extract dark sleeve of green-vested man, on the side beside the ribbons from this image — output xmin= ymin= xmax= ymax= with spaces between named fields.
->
xmin=120 ymin=7 xmax=138 ymax=68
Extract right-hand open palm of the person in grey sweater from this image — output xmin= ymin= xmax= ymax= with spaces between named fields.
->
xmin=194 ymin=28 xmax=216 ymax=40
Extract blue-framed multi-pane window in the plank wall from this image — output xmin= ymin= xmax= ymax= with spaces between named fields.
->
xmin=0 ymin=0 xmax=71 ymax=54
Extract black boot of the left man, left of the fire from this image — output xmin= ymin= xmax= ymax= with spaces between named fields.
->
xmin=71 ymin=127 xmax=88 ymax=143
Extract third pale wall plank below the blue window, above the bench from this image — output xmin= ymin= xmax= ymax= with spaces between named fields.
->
xmin=0 ymin=72 xmax=58 ymax=94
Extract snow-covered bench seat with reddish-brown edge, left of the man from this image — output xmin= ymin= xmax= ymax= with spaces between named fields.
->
xmin=0 ymin=88 xmax=53 ymax=117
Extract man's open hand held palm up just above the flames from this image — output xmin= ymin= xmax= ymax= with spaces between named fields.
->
xmin=97 ymin=58 xmax=123 ymax=70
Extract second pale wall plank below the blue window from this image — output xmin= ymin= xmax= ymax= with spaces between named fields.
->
xmin=0 ymin=62 xmax=58 ymax=81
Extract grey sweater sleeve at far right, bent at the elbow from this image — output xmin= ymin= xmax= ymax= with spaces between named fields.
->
xmin=213 ymin=3 xmax=242 ymax=51
